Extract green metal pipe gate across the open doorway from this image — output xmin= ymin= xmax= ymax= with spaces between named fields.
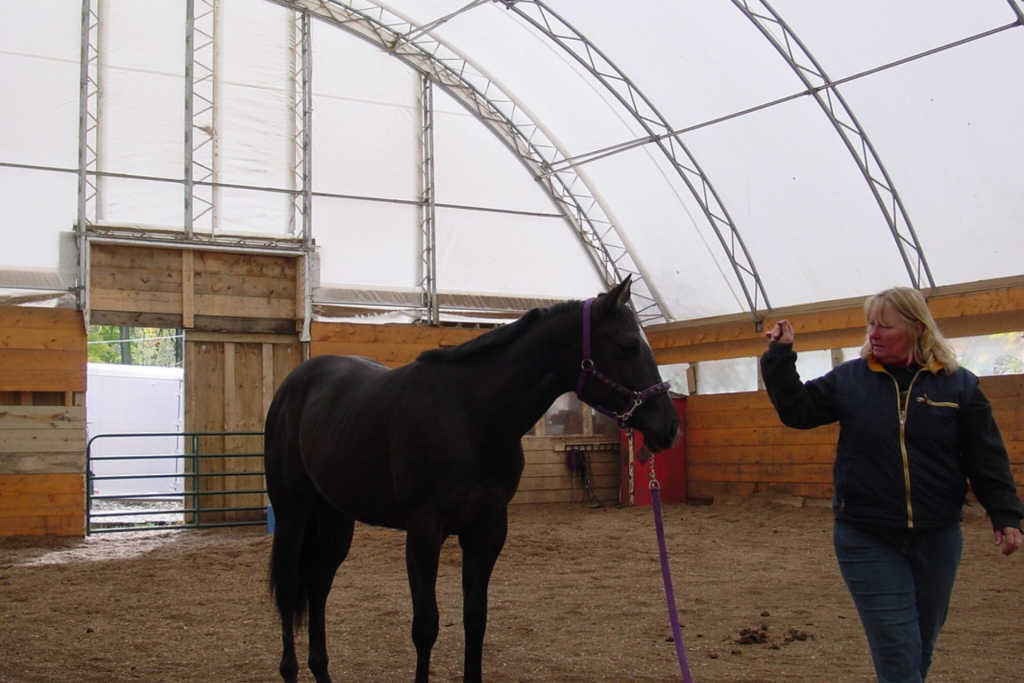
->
xmin=86 ymin=431 xmax=267 ymax=535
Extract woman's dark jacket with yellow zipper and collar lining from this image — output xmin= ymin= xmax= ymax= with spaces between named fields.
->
xmin=761 ymin=343 xmax=1024 ymax=529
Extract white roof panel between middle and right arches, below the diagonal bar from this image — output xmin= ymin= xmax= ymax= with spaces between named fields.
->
xmin=687 ymin=98 xmax=907 ymax=307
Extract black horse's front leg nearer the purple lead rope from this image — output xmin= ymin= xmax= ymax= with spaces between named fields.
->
xmin=459 ymin=510 xmax=508 ymax=683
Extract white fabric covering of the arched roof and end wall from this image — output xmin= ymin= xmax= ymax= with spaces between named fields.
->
xmin=0 ymin=0 xmax=1024 ymax=322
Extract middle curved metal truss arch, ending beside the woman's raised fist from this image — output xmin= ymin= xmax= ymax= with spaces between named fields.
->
xmin=496 ymin=0 xmax=771 ymax=326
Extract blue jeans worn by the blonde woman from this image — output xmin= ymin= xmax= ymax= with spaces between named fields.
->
xmin=833 ymin=521 xmax=964 ymax=683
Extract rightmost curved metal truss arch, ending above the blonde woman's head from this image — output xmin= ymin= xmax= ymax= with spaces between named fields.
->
xmin=732 ymin=0 xmax=935 ymax=289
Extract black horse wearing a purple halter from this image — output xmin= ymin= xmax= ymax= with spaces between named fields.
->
xmin=265 ymin=280 xmax=679 ymax=683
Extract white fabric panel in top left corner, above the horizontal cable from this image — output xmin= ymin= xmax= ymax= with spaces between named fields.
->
xmin=0 ymin=0 xmax=82 ymax=169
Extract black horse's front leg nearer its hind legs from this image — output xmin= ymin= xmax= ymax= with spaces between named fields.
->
xmin=406 ymin=515 xmax=445 ymax=683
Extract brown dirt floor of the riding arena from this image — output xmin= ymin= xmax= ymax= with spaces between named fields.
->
xmin=0 ymin=499 xmax=1024 ymax=683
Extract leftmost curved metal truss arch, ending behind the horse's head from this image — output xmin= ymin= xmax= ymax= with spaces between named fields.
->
xmin=271 ymin=0 xmax=667 ymax=324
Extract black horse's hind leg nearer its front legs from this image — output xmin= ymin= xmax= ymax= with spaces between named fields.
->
xmin=300 ymin=499 xmax=355 ymax=683
